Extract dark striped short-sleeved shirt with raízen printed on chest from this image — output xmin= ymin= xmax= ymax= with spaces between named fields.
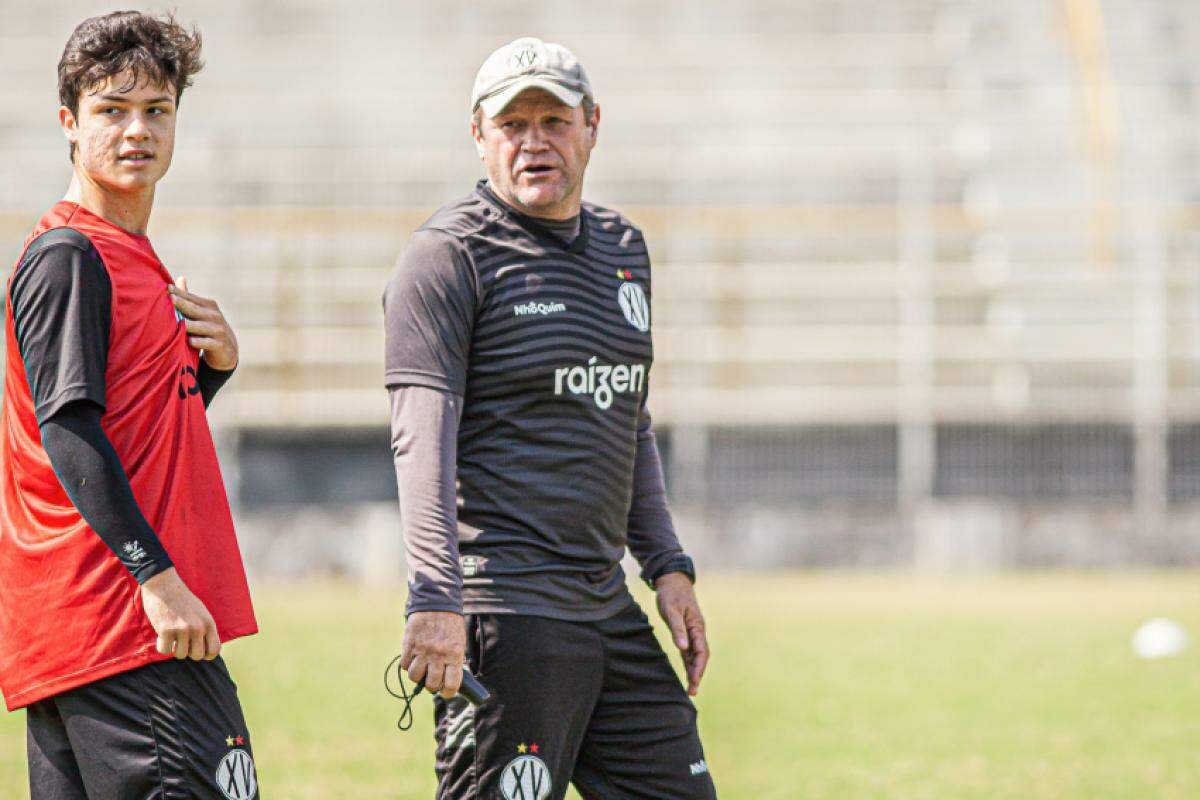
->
xmin=384 ymin=182 xmax=654 ymax=620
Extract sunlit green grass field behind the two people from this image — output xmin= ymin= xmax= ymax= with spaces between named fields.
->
xmin=0 ymin=572 xmax=1200 ymax=800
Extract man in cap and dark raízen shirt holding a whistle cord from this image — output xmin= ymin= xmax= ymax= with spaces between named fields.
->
xmin=384 ymin=38 xmax=715 ymax=800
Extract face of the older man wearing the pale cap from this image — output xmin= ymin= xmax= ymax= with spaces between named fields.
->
xmin=472 ymin=89 xmax=600 ymax=219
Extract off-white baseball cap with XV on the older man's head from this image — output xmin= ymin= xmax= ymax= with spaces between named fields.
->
xmin=470 ymin=36 xmax=592 ymax=116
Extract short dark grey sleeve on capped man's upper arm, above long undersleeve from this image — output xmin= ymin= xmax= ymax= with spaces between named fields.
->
xmin=383 ymin=230 xmax=479 ymax=395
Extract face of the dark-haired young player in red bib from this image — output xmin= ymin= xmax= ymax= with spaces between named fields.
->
xmin=59 ymin=73 xmax=175 ymax=192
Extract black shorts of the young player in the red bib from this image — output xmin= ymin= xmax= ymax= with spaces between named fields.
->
xmin=26 ymin=657 xmax=258 ymax=800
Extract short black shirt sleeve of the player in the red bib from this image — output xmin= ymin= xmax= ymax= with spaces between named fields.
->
xmin=11 ymin=228 xmax=113 ymax=423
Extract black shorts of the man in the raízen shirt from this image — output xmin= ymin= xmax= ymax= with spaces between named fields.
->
xmin=434 ymin=603 xmax=716 ymax=800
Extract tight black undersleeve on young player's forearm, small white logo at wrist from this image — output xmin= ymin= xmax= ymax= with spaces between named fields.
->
xmin=41 ymin=401 xmax=172 ymax=583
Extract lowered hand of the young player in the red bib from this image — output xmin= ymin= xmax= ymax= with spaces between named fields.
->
xmin=142 ymin=567 xmax=221 ymax=661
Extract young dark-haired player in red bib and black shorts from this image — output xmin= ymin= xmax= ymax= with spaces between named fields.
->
xmin=0 ymin=12 xmax=258 ymax=800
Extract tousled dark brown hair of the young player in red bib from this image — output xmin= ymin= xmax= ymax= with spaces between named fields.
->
xmin=59 ymin=11 xmax=204 ymax=157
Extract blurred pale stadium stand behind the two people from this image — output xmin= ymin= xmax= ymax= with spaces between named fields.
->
xmin=0 ymin=0 xmax=1200 ymax=577
